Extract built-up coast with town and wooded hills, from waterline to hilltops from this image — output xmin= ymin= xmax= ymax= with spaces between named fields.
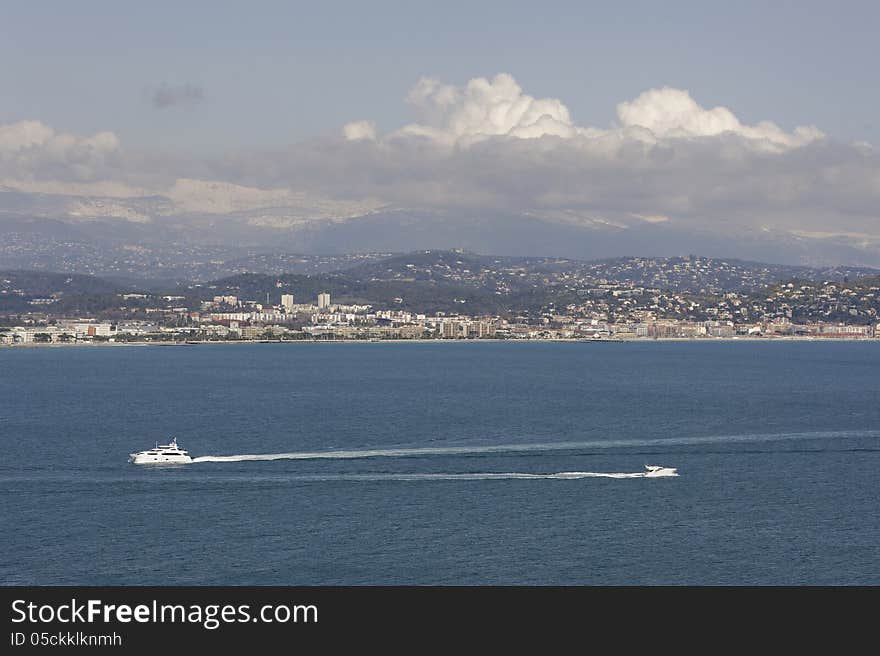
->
xmin=0 ymin=252 xmax=880 ymax=345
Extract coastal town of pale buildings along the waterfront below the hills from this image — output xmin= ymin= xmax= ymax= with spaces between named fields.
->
xmin=0 ymin=282 xmax=880 ymax=346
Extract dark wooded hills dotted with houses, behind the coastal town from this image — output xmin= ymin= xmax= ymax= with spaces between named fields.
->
xmin=0 ymin=251 xmax=880 ymax=320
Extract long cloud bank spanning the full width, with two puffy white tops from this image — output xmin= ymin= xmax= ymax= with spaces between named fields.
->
xmin=0 ymin=74 xmax=880 ymax=261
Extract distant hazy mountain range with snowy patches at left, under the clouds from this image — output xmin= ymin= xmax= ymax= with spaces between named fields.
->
xmin=0 ymin=197 xmax=880 ymax=279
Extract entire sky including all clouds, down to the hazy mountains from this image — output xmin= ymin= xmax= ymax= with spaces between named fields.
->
xmin=0 ymin=0 xmax=880 ymax=265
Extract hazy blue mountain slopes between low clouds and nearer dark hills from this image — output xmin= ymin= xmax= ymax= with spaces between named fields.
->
xmin=6 ymin=202 xmax=875 ymax=283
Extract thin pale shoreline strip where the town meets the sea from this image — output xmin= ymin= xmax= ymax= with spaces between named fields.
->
xmin=0 ymin=336 xmax=880 ymax=350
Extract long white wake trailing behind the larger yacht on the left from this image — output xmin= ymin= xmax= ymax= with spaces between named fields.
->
xmin=193 ymin=431 xmax=880 ymax=464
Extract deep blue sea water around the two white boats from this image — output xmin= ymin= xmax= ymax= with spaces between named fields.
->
xmin=0 ymin=342 xmax=880 ymax=585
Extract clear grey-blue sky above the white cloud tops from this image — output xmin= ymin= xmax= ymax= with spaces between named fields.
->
xmin=6 ymin=0 xmax=880 ymax=154
